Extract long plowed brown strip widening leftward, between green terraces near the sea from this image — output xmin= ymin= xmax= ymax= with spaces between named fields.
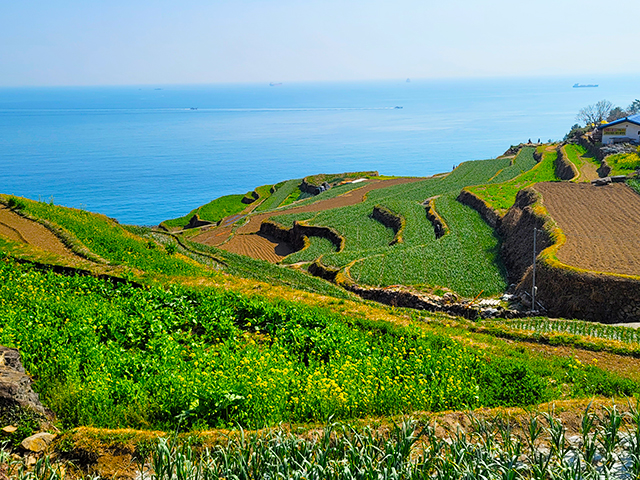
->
xmin=192 ymin=178 xmax=424 ymax=263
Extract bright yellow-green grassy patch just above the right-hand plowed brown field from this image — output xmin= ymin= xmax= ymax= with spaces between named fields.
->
xmin=468 ymin=150 xmax=559 ymax=214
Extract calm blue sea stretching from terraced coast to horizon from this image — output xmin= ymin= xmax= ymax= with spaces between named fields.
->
xmin=0 ymin=76 xmax=640 ymax=225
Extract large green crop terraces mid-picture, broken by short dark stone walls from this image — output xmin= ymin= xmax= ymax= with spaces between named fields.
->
xmin=274 ymin=159 xmax=509 ymax=295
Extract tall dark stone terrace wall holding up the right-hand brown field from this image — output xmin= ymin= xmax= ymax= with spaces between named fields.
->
xmin=500 ymin=188 xmax=640 ymax=323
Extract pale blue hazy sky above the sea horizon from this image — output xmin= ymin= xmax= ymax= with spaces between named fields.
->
xmin=0 ymin=0 xmax=640 ymax=86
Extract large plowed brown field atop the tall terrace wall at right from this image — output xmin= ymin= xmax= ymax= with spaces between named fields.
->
xmin=534 ymin=182 xmax=640 ymax=275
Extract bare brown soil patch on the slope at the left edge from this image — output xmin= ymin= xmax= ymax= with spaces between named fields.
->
xmin=0 ymin=206 xmax=85 ymax=262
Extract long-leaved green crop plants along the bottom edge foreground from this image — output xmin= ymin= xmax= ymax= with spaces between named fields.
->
xmin=18 ymin=405 xmax=640 ymax=480
